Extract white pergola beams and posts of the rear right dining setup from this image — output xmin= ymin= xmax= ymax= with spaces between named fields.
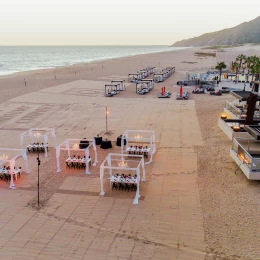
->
xmin=121 ymin=130 xmax=156 ymax=164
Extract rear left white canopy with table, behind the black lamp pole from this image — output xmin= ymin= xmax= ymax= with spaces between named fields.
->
xmin=20 ymin=128 xmax=56 ymax=157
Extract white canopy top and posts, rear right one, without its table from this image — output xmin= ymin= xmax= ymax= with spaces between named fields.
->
xmin=121 ymin=130 xmax=156 ymax=164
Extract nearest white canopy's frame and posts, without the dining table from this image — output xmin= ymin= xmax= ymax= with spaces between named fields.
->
xmin=100 ymin=153 xmax=146 ymax=204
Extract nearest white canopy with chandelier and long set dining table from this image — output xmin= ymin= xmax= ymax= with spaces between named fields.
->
xmin=100 ymin=153 xmax=146 ymax=204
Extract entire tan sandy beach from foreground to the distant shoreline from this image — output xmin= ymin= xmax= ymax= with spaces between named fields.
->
xmin=0 ymin=46 xmax=260 ymax=260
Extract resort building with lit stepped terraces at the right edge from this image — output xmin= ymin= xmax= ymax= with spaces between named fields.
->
xmin=218 ymin=82 xmax=260 ymax=180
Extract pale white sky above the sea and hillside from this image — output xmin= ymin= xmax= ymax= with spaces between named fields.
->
xmin=0 ymin=0 xmax=260 ymax=45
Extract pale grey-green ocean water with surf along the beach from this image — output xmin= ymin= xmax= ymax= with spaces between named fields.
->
xmin=0 ymin=46 xmax=183 ymax=75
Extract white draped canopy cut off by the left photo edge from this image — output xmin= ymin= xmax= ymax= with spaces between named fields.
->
xmin=0 ymin=148 xmax=29 ymax=189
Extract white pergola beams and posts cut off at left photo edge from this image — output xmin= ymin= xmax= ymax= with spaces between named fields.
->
xmin=0 ymin=148 xmax=30 ymax=189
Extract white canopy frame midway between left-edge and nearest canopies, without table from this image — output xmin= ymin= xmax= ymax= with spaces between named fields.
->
xmin=56 ymin=139 xmax=98 ymax=174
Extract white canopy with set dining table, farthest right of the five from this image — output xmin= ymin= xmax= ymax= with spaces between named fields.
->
xmin=121 ymin=130 xmax=156 ymax=164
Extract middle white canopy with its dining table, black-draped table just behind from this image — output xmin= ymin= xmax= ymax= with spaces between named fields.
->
xmin=56 ymin=139 xmax=98 ymax=174
